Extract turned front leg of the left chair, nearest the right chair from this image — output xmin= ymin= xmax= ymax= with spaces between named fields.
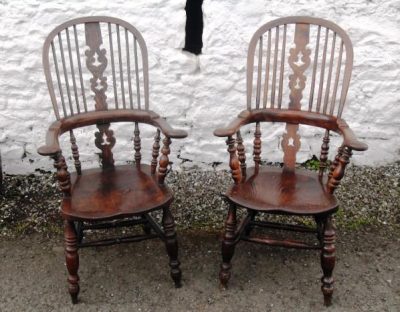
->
xmin=162 ymin=207 xmax=182 ymax=288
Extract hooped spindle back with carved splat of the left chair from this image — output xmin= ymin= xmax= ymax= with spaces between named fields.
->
xmin=43 ymin=16 xmax=149 ymax=174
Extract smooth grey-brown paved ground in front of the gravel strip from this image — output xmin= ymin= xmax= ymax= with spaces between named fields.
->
xmin=0 ymin=229 xmax=400 ymax=312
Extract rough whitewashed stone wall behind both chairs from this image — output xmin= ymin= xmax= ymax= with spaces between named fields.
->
xmin=0 ymin=0 xmax=400 ymax=173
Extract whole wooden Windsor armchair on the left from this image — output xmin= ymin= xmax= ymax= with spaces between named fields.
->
xmin=38 ymin=17 xmax=187 ymax=303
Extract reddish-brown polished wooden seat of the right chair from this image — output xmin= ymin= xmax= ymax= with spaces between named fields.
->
xmin=227 ymin=167 xmax=338 ymax=215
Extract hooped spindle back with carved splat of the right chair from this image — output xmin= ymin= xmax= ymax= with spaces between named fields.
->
xmin=247 ymin=16 xmax=353 ymax=176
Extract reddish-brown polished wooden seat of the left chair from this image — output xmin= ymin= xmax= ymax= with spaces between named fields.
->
xmin=61 ymin=165 xmax=173 ymax=221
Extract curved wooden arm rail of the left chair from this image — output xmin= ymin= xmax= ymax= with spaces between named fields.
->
xmin=38 ymin=109 xmax=187 ymax=156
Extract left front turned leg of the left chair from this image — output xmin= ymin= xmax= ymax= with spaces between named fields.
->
xmin=64 ymin=220 xmax=79 ymax=304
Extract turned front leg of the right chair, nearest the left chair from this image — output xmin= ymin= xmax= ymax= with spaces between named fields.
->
xmin=219 ymin=203 xmax=237 ymax=288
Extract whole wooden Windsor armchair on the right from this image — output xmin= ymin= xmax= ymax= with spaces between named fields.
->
xmin=214 ymin=17 xmax=367 ymax=305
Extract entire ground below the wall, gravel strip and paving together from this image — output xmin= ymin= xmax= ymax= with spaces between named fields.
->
xmin=0 ymin=163 xmax=400 ymax=312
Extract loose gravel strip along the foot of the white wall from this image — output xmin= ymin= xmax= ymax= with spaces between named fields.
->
xmin=0 ymin=162 xmax=400 ymax=236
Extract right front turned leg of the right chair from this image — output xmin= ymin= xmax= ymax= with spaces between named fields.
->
xmin=321 ymin=216 xmax=336 ymax=306
